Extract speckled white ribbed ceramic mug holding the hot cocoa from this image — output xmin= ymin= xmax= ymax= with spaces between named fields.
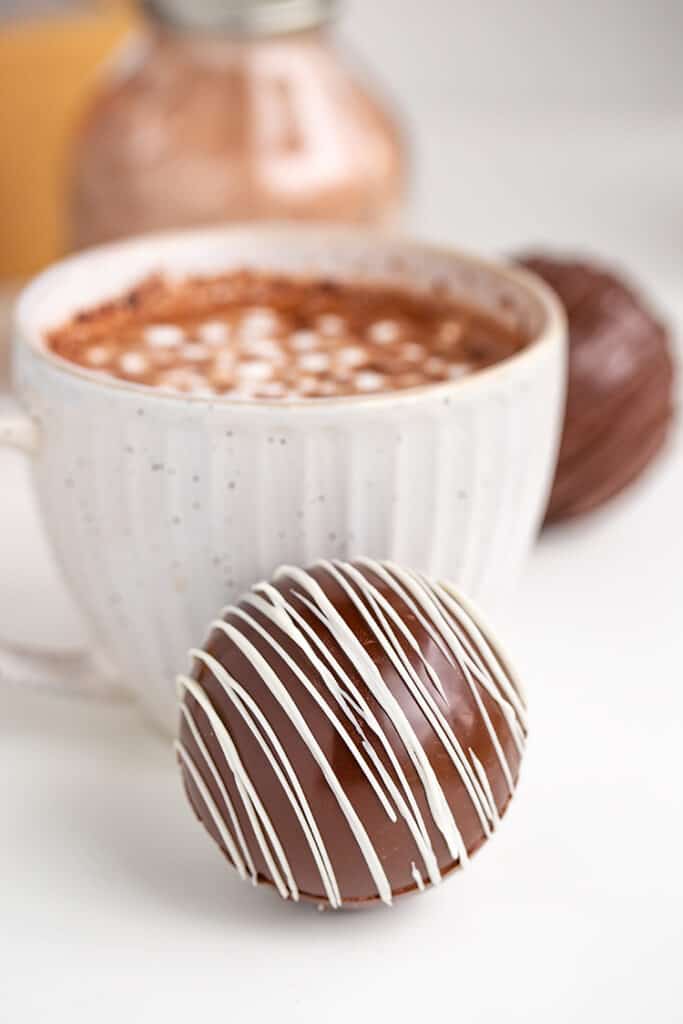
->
xmin=0 ymin=226 xmax=565 ymax=730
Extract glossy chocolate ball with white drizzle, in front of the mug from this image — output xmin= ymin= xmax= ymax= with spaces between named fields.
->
xmin=177 ymin=559 xmax=526 ymax=908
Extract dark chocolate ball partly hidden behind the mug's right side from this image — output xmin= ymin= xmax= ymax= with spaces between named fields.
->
xmin=519 ymin=255 xmax=674 ymax=521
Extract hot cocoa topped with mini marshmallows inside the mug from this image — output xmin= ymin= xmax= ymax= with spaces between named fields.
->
xmin=47 ymin=270 xmax=528 ymax=400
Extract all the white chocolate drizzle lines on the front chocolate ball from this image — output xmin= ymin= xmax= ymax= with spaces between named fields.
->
xmin=177 ymin=559 xmax=526 ymax=908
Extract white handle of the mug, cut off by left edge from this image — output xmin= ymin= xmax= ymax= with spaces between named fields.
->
xmin=0 ymin=411 xmax=128 ymax=699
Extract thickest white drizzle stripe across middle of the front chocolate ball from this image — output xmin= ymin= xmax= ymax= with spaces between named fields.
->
xmin=275 ymin=563 xmax=467 ymax=859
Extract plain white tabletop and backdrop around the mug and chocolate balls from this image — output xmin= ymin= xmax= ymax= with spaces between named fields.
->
xmin=0 ymin=0 xmax=683 ymax=1024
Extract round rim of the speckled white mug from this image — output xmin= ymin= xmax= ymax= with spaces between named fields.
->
xmin=11 ymin=221 xmax=566 ymax=413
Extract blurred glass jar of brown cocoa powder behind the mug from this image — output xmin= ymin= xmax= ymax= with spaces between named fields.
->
xmin=71 ymin=0 xmax=405 ymax=248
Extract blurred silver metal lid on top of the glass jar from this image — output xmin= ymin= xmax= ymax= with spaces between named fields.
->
xmin=142 ymin=0 xmax=338 ymax=36
